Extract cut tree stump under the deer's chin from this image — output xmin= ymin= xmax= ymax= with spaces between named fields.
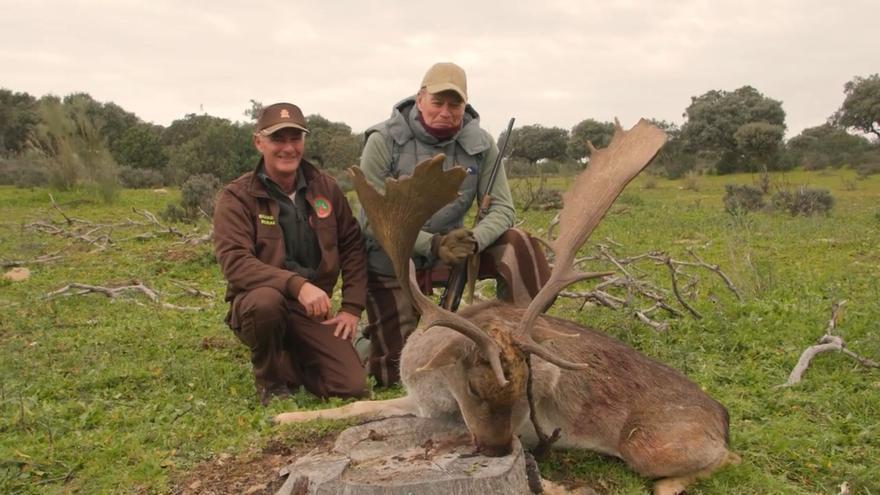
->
xmin=276 ymin=417 xmax=532 ymax=495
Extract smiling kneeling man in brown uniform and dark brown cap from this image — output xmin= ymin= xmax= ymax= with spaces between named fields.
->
xmin=214 ymin=103 xmax=367 ymax=405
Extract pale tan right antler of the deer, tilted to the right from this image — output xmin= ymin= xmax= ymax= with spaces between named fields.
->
xmin=515 ymin=119 xmax=666 ymax=367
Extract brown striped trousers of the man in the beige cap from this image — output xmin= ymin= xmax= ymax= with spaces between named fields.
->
xmin=364 ymin=229 xmax=550 ymax=386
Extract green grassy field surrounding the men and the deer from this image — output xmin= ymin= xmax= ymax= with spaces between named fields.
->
xmin=0 ymin=171 xmax=880 ymax=495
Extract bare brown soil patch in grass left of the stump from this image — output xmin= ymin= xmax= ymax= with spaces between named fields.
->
xmin=171 ymin=433 xmax=336 ymax=495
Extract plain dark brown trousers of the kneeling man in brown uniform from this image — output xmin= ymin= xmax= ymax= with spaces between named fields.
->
xmin=229 ymin=287 xmax=367 ymax=398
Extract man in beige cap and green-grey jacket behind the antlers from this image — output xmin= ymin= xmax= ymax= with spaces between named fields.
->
xmin=360 ymin=63 xmax=550 ymax=385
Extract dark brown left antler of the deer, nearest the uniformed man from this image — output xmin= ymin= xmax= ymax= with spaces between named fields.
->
xmin=350 ymin=154 xmax=507 ymax=386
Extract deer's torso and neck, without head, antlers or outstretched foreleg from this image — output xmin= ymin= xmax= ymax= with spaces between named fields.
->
xmin=401 ymin=302 xmax=728 ymax=478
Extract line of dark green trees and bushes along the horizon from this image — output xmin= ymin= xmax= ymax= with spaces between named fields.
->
xmin=0 ymin=80 xmax=880 ymax=191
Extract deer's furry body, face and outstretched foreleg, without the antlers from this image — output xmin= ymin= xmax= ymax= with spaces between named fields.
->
xmin=275 ymin=301 xmax=739 ymax=495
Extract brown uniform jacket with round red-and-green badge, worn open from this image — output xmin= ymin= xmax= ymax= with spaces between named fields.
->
xmin=214 ymin=160 xmax=367 ymax=316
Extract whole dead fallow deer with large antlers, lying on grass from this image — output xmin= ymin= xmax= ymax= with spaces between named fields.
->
xmin=275 ymin=120 xmax=739 ymax=495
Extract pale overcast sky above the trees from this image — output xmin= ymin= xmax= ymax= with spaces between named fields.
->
xmin=0 ymin=0 xmax=880 ymax=137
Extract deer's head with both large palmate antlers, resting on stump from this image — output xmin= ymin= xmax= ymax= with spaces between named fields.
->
xmin=351 ymin=119 xmax=666 ymax=455
